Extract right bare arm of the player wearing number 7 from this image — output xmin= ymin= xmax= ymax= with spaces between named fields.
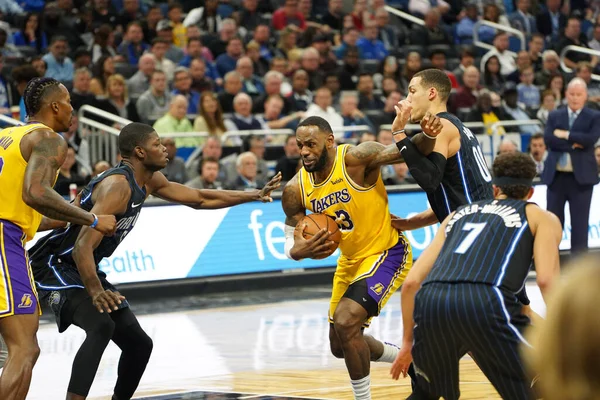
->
xmin=526 ymin=204 xmax=562 ymax=300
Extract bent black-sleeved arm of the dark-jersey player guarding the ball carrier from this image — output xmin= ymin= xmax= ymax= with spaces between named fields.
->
xmin=396 ymin=119 xmax=460 ymax=193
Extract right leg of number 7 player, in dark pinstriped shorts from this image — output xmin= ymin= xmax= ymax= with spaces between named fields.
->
xmin=463 ymin=285 xmax=534 ymax=400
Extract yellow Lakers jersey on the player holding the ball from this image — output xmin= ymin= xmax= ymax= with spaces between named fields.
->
xmin=299 ymin=145 xmax=398 ymax=259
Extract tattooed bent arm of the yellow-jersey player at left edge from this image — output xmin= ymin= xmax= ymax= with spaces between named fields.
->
xmin=22 ymin=130 xmax=116 ymax=234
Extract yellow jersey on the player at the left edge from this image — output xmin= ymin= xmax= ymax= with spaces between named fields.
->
xmin=0 ymin=124 xmax=49 ymax=240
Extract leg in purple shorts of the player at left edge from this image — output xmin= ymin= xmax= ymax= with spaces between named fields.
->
xmin=0 ymin=221 xmax=40 ymax=400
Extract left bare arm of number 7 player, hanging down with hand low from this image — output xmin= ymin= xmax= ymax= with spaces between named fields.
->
xmin=391 ymin=213 xmax=454 ymax=379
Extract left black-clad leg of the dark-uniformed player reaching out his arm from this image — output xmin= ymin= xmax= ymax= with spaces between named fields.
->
xmin=66 ymin=289 xmax=115 ymax=400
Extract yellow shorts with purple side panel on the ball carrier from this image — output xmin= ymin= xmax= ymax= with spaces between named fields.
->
xmin=329 ymin=234 xmax=413 ymax=328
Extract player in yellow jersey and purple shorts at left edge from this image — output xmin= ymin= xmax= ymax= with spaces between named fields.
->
xmin=0 ymin=78 xmax=116 ymax=400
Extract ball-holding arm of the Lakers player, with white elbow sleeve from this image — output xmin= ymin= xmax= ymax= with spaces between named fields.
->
xmin=281 ymin=174 xmax=331 ymax=261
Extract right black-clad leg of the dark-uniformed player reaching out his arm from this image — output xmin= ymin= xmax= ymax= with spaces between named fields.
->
xmin=111 ymin=307 xmax=152 ymax=400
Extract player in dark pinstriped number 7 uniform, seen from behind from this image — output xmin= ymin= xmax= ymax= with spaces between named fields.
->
xmin=392 ymin=153 xmax=562 ymax=400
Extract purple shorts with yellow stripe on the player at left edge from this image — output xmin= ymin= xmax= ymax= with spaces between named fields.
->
xmin=0 ymin=219 xmax=41 ymax=318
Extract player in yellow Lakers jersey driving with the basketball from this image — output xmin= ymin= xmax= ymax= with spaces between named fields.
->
xmin=282 ymin=116 xmax=442 ymax=400
